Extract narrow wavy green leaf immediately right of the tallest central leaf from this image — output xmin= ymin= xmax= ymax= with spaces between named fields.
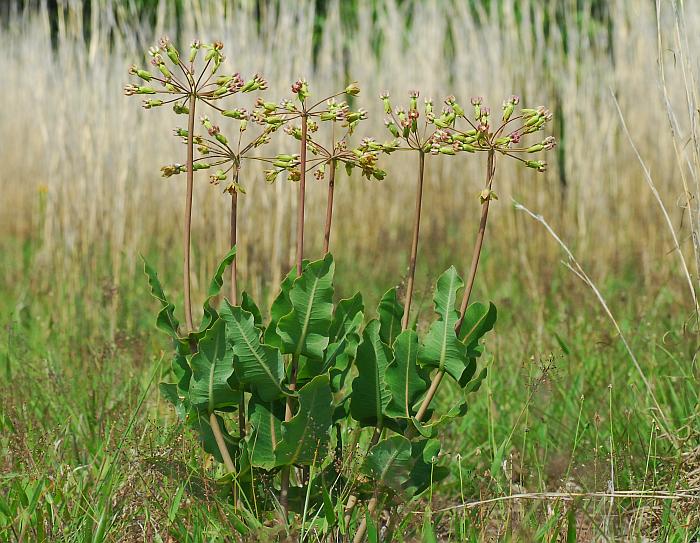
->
xmin=321 ymin=292 xmax=364 ymax=391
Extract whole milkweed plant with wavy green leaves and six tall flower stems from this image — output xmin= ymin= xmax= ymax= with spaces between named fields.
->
xmin=125 ymin=38 xmax=555 ymax=542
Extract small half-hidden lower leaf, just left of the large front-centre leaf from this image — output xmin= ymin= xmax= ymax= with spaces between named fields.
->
xmin=246 ymin=396 xmax=284 ymax=470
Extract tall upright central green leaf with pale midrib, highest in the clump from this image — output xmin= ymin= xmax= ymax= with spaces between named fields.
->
xmin=277 ymin=254 xmax=335 ymax=366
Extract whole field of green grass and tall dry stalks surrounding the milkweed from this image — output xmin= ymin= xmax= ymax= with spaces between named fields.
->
xmin=0 ymin=0 xmax=700 ymax=541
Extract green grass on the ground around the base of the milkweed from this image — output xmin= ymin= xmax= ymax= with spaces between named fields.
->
xmin=0 ymin=244 xmax=700 ymax=542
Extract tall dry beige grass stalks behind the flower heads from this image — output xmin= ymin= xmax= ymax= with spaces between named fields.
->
xmin=0 ymin=0 xmax=700 ymax=314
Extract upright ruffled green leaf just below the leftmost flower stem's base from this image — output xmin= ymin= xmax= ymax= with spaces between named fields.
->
xmin=190 ymin=319 xmax=238 ymax=413
